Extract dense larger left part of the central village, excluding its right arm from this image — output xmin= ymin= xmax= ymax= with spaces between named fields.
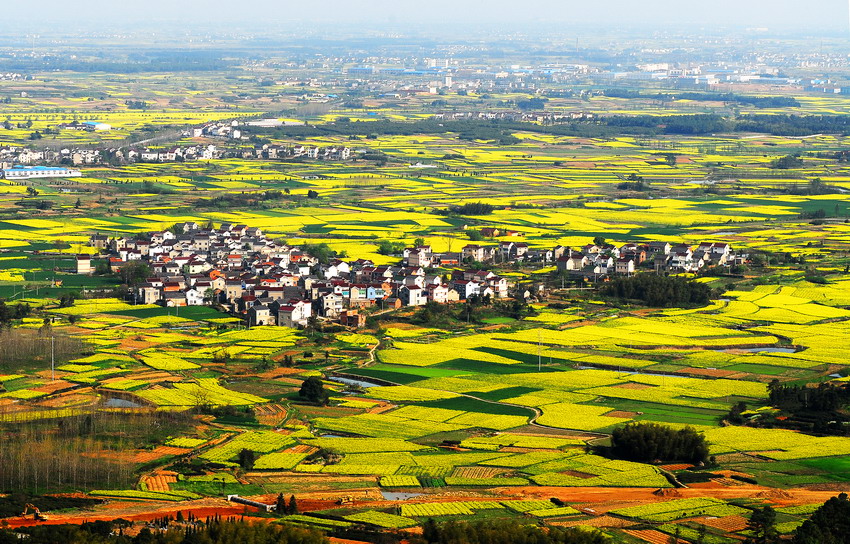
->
xmin=77 ymin=222 xmax=509 ymax=327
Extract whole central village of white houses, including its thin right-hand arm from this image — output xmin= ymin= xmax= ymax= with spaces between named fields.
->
xmin=77 ymin=222 xmax=747 ymax=327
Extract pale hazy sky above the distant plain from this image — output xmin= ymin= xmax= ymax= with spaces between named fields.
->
xmin=9 ymin=0 xmax=850 ymax=34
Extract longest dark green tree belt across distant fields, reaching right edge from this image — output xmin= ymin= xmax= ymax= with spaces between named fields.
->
xmin=250 ymin=114 xmax=850 ymax=145
